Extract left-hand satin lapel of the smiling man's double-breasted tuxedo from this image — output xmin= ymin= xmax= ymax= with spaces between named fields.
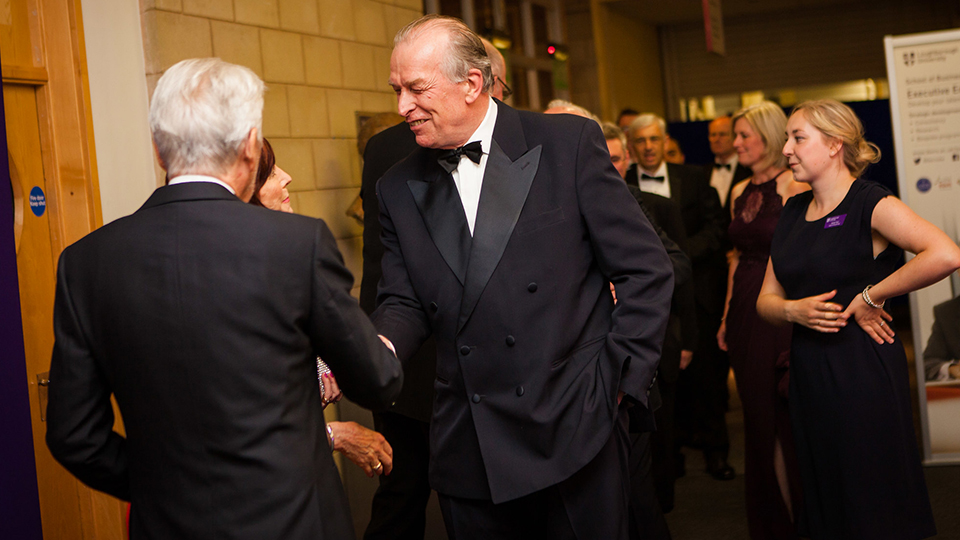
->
xmin=407 ymin=166 xmax=472 ymax=285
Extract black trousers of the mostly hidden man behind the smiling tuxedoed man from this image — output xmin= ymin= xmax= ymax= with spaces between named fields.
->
xmin=363 ymin=412 xmax=430 ymax=540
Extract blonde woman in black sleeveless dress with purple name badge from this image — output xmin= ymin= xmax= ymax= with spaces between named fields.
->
xmin=757 ymin=100 xmax=960 ymax=540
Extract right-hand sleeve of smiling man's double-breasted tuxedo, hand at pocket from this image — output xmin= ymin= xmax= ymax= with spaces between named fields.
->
xmin=577 ymin=121 xmax=673 ymax=406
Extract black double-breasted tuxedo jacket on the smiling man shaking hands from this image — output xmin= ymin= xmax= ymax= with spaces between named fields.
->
xmin=373 ymin=102 xmax=673 ymax=503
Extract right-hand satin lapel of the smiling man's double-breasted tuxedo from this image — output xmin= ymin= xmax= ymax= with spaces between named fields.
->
xmin=457 ymin=139 xmax=542 ymax=333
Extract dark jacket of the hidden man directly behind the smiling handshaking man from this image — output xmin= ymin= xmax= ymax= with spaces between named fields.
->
xmin=360 ymin=122 xmax=437 ymax=422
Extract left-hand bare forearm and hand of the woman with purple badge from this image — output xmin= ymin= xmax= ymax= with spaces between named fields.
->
xmin=757 ymin=260 xmax=847 ymax=334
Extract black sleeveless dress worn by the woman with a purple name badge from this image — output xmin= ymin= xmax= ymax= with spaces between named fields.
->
xmin=771 ymin=180 xmax=936 ymax=540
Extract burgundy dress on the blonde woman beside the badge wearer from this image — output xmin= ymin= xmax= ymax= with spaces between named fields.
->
xmin=727 ymin=175 xmax=800 ymax=540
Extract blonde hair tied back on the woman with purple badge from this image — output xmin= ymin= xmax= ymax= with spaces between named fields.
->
xmin=790 ymin=99 xmax=880 ymax=177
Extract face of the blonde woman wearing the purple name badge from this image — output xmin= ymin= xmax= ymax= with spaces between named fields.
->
xmin=783 ymin=111 xmax=843 ymax=182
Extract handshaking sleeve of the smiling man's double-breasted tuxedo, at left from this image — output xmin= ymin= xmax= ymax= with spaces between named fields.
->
xmin=371 ymin=182 xmax=432 ymax=362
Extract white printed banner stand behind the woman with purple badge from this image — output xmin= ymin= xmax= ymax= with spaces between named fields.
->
xmin=884 ymin=30 xmax=960 ymax=463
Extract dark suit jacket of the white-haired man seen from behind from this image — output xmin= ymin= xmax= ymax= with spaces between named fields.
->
xmin=47 ymin=183 xmax=402 ymax=540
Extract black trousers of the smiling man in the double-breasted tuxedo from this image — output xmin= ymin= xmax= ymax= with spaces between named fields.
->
xmin=439 ymin=410 xmax=630 ymax=540
